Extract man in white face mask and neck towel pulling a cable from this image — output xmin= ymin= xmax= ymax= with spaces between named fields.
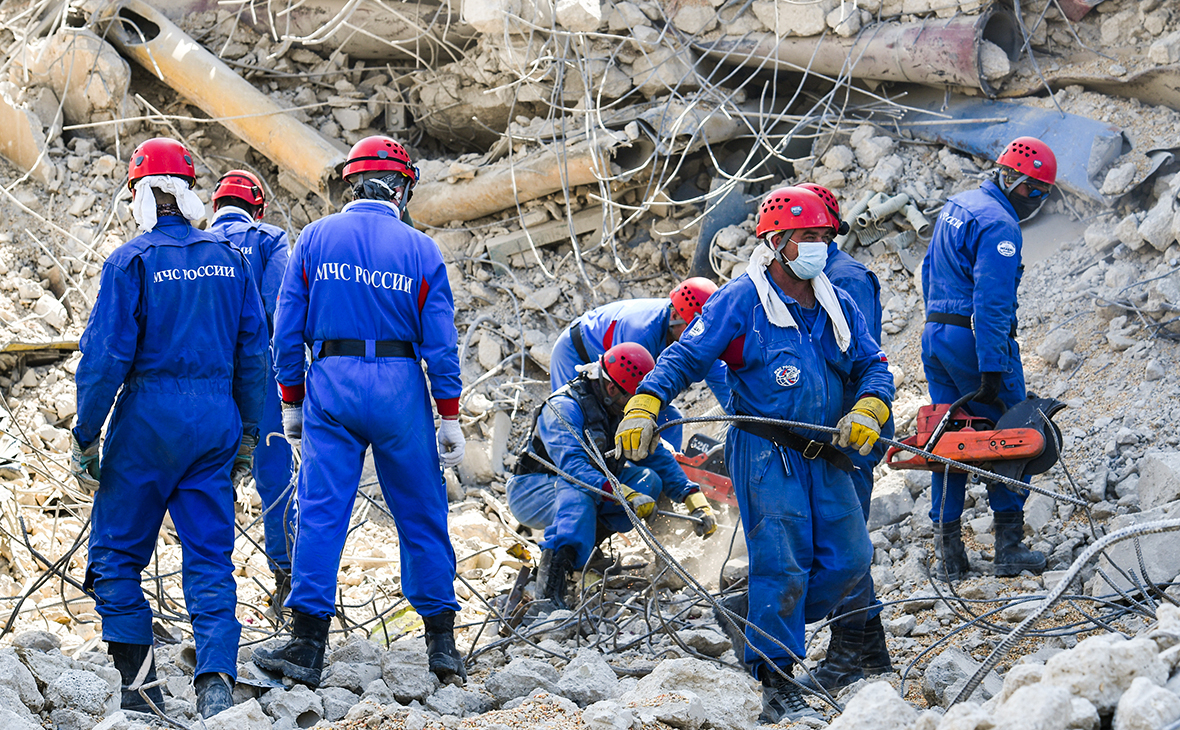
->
xmin=617 ymin=188 xmax=893 ymax=723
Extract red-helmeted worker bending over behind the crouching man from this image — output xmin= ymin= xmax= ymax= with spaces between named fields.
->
xmin=549 ymin=276 xmax=729 ymax=452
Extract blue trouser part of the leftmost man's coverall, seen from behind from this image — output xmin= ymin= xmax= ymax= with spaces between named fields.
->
xmin=86 ymin=389 xmax=242 ymax=677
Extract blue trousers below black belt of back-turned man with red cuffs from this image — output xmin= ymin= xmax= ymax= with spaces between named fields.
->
xmin=286 ymin=357 xmax=459 ymax=619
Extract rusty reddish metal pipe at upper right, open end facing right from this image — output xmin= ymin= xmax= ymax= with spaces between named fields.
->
xmin=693 ymin=5 xmax=1023 ymax=97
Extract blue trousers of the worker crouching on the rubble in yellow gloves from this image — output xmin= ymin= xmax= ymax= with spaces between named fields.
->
xmin=507 ymin=463 xmax=663 ymax=566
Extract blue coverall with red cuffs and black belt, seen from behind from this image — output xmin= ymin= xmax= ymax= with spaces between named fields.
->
xmin=274 ymin=200 xmax=461 ymax=619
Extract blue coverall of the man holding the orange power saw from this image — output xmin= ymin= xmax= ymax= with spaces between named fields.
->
xmin=922 ymin=180 xmax=1025 ymax=522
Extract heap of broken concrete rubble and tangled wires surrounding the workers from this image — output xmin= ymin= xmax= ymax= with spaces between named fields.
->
xmin=0 ymin=0 xmax=1180 ymax=730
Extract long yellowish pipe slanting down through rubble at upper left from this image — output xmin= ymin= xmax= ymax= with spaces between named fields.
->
xmin=97 ymin=0 xmax=348 ymax=198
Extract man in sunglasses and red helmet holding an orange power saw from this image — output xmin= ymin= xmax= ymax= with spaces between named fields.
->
xmin=922 ymin=137 xmax=1057 ymax=580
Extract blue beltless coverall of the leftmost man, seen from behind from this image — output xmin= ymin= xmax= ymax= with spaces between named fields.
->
xmin=73 ymin=216 xmax=267 ymax=677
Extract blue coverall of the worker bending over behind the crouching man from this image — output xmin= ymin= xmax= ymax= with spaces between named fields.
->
xmin=549 ymin=300 xmax=729 ymax=452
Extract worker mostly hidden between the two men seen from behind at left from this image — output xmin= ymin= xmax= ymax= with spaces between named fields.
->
xmin=210 ymin=170 xmax=295 ymax=614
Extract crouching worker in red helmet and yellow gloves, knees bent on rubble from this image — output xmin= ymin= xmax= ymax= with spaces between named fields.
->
xmin=507 ymin=342 xmax=716 ymax=609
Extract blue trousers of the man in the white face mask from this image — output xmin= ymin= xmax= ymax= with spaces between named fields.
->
xmin=726 ymin=428 xmax=873 ymax=677
